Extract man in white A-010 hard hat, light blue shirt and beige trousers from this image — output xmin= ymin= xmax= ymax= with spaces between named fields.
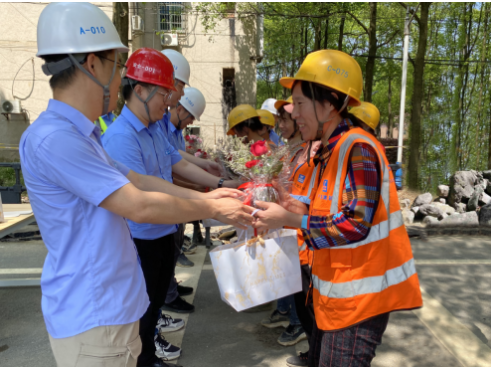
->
xmin=19 ymin=3 xmax=253 ymax=367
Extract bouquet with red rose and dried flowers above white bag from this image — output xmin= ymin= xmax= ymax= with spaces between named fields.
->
xmin=210 ymin=136 xmax=291 ymax=205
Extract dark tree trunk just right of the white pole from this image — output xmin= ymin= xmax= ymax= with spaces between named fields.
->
xmin=407 ymin=3 xmax=431 ymax=190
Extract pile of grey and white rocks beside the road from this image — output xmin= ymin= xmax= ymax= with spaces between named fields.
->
xmin=401 ymin=170 xmax=491 ymax=226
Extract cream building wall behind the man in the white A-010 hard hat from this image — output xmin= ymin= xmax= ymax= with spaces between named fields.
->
xmin=0 ymin=2 xmax=112 ymax=161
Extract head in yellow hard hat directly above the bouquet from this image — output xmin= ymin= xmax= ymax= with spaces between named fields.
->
xmin=227 ymin=104 xmax=276 ymax=149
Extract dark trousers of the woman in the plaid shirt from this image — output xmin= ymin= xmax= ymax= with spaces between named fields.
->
xmin=309 ymin=313 xmax=389 ymax=367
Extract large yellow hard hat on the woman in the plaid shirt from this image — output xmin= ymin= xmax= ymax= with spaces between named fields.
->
xmin=280 ymin=50 xmax=363 ymax=106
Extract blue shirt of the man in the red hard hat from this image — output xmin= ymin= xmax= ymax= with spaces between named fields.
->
xmin=102 ymin=106 xmax=182 ymax=240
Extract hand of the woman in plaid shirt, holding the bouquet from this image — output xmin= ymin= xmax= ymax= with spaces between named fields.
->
xmin=254 ymin=201 xmax=302 ymax=232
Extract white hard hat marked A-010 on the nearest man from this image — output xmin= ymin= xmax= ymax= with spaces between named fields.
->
xmin=36 ymin=2 xmax=129 ymax=56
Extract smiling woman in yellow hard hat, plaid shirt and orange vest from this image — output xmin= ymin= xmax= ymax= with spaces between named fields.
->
xmin=254 ymin=50 xmax=422 ymax=367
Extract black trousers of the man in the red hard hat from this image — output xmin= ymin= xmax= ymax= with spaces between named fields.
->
xmin=134 ymin=234 xmax=175 ymax=364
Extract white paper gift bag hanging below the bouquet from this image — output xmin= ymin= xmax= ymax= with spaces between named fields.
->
xmin=210 ymin=229 xmax=302 ymax=311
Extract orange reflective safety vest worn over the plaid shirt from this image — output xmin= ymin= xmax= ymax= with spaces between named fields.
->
xmin=309 ymin=128 xmax=423 ymax=331
